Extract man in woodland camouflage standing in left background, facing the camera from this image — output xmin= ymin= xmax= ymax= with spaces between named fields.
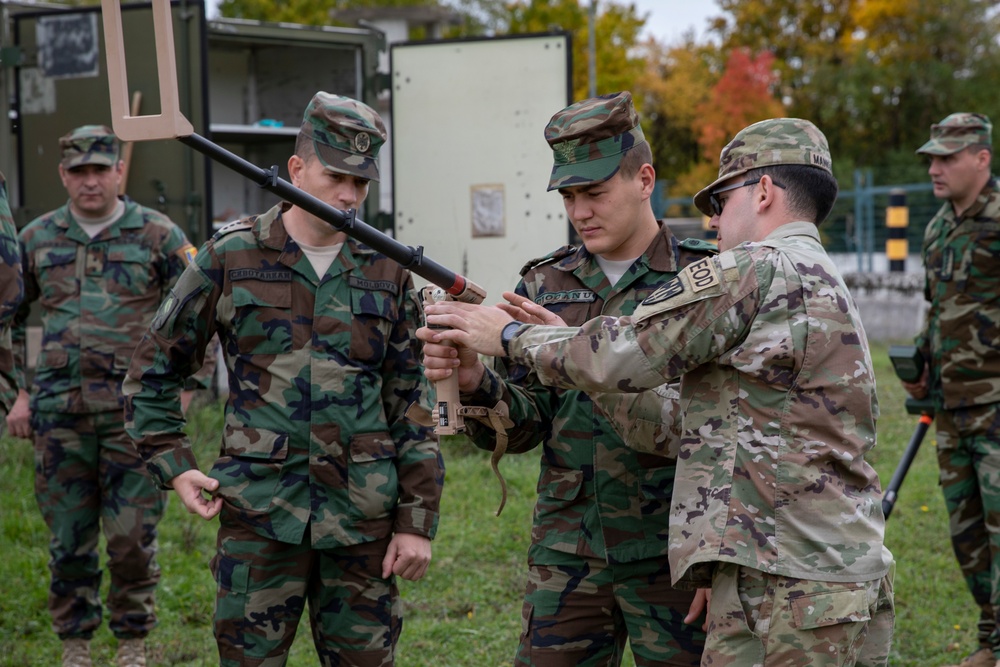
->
xmin=7 ymin=125 xmax=209 ymax=666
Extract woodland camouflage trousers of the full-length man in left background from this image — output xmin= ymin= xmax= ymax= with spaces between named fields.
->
xmin=32 ymin=410 xmax=166 ymax=639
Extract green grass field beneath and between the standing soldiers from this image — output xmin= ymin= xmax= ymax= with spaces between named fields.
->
xmin=0 ymin=346 xmax=977 ymax=667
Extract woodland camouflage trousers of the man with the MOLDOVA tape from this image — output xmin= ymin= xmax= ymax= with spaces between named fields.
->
xmin=212 ymin=509 xmax=402 ymax=667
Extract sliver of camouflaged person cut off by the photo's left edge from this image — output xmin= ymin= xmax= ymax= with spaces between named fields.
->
xmin=0 ymin=174 xmax=24 ymax=435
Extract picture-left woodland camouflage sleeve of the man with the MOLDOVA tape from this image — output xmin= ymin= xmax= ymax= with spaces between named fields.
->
xmin=122 ymin=252 xmax=221 ymax=488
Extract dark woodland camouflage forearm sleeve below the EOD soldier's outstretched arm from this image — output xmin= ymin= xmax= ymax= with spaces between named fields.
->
xmin=462 ymin=280 xmax=559 ymax=453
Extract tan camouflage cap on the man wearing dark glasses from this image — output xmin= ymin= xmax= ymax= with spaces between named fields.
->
xmin=694 ymin=118 xmax=833 ymax=216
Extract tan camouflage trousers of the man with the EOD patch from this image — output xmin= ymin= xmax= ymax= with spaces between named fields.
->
xmin=701 ymin=563 xmax=895 ymax=667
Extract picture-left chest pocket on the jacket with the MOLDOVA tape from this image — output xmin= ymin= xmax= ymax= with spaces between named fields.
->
xmin=233 ymin=280 xmax=292 ymax=354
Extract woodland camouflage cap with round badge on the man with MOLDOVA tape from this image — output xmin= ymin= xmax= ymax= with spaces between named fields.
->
xmin=299 ymin=91 xmax=386 ymax=182
